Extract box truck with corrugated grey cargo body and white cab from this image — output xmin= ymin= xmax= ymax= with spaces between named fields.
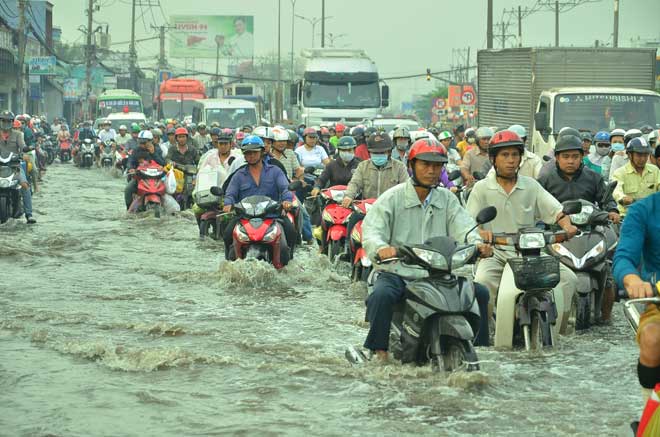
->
xmin=477 ymin=47 xmax=660 ymax=154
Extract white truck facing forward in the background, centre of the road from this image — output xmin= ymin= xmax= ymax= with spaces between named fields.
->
xmin=290 ymin=48 xmax=389 ymax=126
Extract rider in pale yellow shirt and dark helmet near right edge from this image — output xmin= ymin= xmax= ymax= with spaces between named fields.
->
xmin=612 ymin=137 xmax=660 ymax=217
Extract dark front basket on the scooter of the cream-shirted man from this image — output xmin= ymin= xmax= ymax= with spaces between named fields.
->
xmin=508 ymin=256 xmax=559 ymax=291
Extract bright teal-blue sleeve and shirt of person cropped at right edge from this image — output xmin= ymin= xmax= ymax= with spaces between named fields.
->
xmin=613 ymin=193 xmax=660 ymax=288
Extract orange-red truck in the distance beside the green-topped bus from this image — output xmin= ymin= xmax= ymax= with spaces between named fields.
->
xmin=156 ymin=78 xmax=206 ymax=120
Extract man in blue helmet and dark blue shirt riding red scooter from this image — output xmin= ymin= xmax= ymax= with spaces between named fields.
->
xmin=223 ymin=135 xmax=296 ymax=264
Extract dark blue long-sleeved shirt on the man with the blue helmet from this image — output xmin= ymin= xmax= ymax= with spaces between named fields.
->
xmin=224 ymin=163 xmax=293 ymax=205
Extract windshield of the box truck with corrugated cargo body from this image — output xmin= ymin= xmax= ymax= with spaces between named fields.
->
xmin=553 ymin=94 xmax=660 ymax=132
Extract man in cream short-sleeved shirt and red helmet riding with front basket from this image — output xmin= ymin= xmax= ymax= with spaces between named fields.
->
xmin=467 ymin=130 xmax=578 ymax=333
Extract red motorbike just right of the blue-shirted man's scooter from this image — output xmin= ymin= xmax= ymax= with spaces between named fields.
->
xmin=321 ymin=185 xmax=353 ymax=261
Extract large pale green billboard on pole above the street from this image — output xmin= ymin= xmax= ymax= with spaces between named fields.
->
xmin=170 ymin=15 xmax=254 ymax=59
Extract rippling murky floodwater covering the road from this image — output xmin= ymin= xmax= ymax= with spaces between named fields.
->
xmin=0 ymin=164 xmax=642 ymax=436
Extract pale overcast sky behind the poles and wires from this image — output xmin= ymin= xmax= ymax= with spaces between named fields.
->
xmin=50 ymin=0 xmax=660 ymax=108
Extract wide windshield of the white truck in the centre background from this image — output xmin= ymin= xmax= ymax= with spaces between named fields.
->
xmin=303 ymin=81 xmax=380 ymax=108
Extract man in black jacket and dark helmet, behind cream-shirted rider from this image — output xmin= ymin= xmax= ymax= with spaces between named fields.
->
xmin=538 ymin=135 xmax=621 ymax=322
